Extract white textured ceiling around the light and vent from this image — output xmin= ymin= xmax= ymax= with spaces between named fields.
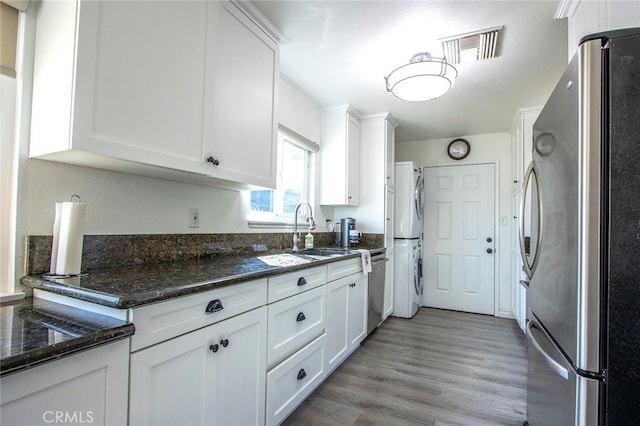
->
xmin=254 ymin=0 xmax=567 ymax=142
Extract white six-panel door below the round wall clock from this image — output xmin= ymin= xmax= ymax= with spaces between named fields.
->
xmin=422 ymin=164 xmax=495 ymax=315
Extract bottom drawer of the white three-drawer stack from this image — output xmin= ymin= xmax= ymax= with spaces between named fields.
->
xmin=267 ymin=334 xmax=325 ymax=425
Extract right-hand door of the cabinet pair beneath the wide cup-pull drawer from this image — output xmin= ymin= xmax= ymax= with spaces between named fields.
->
xmin=214 ymin=307 xmax=267 ymax=425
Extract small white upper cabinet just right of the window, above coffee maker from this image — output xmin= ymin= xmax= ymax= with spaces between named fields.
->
xmin=320 ymin=105 xmax=360 ymax=206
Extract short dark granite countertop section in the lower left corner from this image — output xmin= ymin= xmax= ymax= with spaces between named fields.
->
xmin=0 ymin=298 xmax=134 ymax=376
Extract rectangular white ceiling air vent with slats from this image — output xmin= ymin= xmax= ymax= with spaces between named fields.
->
xmin=440 ymin=26 xmax=502 ymax=65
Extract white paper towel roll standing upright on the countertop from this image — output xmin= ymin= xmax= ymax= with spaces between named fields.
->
xmin=55 ymin=202 xmax=86 ymax=275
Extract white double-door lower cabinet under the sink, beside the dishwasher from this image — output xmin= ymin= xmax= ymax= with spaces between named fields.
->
xmin=326 ymin=273 xmax=367 ymax=373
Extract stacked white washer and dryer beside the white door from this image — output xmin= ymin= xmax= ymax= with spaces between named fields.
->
xmin=391 ymin=161 xmax=424 ymax=318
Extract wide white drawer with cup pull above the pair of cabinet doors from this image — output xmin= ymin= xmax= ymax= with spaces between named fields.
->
xmin=131 ymin=278 xmax=267 ymax=352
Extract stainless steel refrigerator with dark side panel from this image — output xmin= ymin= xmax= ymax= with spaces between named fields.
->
xmin=521 ymin=28 xmax=640 ymax=426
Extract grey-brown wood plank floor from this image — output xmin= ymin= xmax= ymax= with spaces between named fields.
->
xmin=285 ymin=308 xmax=527 ymax=426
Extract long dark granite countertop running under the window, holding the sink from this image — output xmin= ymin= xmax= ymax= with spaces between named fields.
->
xmin=21 ymin=247 xmax=384 ymax=309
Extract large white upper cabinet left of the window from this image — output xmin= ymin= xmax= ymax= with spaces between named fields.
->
xmin=30 ymin=1 xmax=279 ymax=187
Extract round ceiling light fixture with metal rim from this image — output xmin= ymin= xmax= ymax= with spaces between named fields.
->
xmin=384 ymin=52 xmax=458 ymax=101
